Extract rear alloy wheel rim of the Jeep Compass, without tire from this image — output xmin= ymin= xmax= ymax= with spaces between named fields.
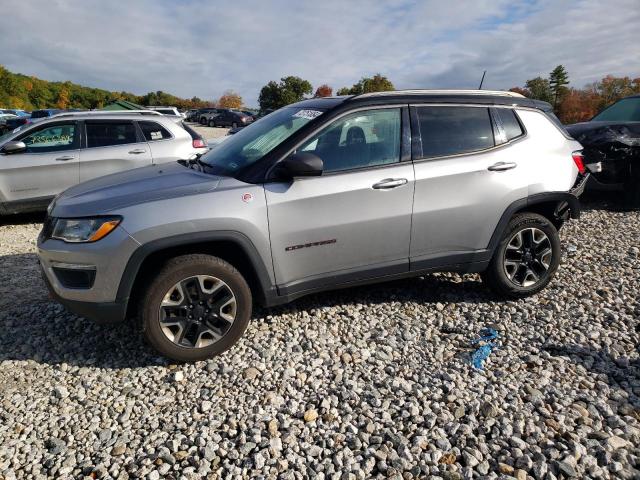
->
xmin=503 ymin=228 xmax=553 ymax=288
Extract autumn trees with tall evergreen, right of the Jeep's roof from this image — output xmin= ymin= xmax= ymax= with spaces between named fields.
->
xmin=511 ymin=65 xmax=640 ymax=124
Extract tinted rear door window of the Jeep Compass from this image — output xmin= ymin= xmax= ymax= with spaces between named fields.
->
xmin=415 ymin=106 xmax=495 ymax=158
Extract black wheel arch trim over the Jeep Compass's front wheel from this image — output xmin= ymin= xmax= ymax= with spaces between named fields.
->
xmin=116 ymin=230 xmax=276 ymax=312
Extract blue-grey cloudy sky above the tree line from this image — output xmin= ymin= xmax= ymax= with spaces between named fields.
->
xmin=0 ymin=0 xmax=640 ymax=106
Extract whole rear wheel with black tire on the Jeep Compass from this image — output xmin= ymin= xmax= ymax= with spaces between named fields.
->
xmin=481 ymin=213 xmax=561 ymax=298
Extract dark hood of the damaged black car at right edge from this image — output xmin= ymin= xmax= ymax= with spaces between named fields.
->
xmin=566 ymin=122 xmax=640 ymax=147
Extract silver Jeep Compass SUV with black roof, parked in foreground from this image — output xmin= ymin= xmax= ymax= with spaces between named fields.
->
xmin=38 ymin=91 xmax=587 ymax=361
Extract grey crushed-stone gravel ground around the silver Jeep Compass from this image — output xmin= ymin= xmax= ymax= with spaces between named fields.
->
xmin=0 ymin=197 xmax=640 ymax=480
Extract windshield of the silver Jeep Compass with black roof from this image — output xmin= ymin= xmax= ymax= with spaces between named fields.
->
xmin=201 ymin=107 xmax=323 ymax=176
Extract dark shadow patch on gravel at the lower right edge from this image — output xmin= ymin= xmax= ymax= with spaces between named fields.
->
xmin=544 ymin=344 xmax=640 ymax=410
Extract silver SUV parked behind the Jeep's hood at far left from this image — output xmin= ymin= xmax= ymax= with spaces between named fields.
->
xmin=0 ymin=110 xmax=208 ymax=215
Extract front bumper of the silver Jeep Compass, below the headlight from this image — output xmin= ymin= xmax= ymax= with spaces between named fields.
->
xmin=37 ymin=226 xmax=139 ymax=323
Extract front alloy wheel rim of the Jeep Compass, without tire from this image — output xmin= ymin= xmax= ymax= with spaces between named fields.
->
xmin=160 ymin=275 xmax=237 ymax=348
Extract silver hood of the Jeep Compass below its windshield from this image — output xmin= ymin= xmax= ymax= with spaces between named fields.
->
xmin=49 ymin=163 xmax=222 ymax=217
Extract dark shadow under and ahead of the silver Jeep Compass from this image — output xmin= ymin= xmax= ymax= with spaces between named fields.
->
xmin=0 ymin=248 xmax=493 ymax=369
